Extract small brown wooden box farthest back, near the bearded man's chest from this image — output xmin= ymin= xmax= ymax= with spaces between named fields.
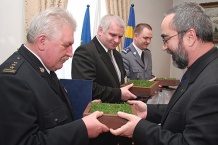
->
xmin=156 ymin=78 xmax=180 ymax=86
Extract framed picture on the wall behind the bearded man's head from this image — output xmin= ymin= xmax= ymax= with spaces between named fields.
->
xmin=200 ymin=2 xmax=218 ymax=43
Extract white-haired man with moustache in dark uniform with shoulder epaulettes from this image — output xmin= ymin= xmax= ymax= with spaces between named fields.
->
xmin=0 ymin=8 xmax=109 ymax=145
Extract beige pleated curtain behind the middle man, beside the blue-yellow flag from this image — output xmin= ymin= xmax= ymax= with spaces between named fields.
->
xmin=106 ymin=0 xmax=130 ymax=52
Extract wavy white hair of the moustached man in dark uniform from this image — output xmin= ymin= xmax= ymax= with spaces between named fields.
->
xmin=27 ymin=7 xmax=76 ymax=43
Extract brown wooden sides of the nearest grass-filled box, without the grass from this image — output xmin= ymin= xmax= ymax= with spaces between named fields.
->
xmin=83 ymin=103 xmax=136 ymax=129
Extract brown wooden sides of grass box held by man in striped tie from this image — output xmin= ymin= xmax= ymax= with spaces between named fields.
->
xmin=121 ymin=80 xmax=158 ymax=97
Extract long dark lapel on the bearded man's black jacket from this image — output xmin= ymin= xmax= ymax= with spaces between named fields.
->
xmin=161 ymin=48 xmax=218 ymax=125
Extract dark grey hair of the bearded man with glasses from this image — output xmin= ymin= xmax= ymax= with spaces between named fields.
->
xmin=165 ymin=2 xmax=213 ymax=42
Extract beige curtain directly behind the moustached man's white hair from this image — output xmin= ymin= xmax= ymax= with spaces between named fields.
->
xmin=24 ymin=0 xmax=68 ymax=39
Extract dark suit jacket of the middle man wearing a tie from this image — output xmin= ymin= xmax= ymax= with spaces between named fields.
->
xmin=72 ymin=37 xmax=125 ymax=103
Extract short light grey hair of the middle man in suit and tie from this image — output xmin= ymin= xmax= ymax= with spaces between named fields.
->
xmin=99 ymin=14 xmax=125 ymax=32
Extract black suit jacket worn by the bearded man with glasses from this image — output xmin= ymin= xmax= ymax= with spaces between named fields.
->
xmin=133 ymin=48 xmax=218 ymax=145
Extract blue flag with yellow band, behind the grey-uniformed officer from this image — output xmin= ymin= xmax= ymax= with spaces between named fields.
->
xmin=124 ymin=4 xmax=135 ymax=48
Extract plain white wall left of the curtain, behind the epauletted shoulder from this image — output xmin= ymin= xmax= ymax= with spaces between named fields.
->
xmin=0 ymin=0 xmax=24 ymax=64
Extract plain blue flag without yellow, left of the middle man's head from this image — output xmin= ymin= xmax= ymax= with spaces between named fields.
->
xmin=81 ymin=5 xmax=91 ymax=44
